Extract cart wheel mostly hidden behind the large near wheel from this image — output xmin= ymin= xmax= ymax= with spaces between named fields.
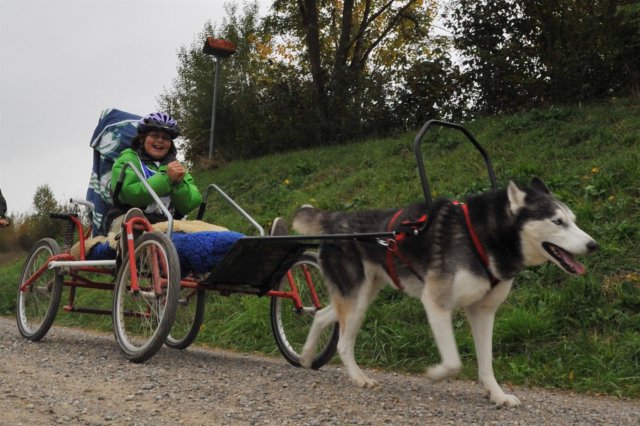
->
xmin=164 ymin=287 xmax=207 ymax=349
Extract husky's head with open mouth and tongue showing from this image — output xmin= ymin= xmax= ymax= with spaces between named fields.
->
xmin=507 ymin=178 xmax=597 ymax=275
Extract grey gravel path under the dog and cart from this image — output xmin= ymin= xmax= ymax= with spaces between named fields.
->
xmin=0 ymin=318 xmax=640 ymax=426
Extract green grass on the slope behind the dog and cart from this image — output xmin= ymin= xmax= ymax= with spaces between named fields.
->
xmin=0 ymin=99 xmax=640 ymax=398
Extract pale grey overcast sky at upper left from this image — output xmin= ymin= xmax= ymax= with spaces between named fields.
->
xmin=0 ymin=0 xmax=269 ymax=213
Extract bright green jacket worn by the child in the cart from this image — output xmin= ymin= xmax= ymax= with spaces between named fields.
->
xmin=111 ymin=148 xmax=202 ymax=216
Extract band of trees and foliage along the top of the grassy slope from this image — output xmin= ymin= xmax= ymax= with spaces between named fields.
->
xmin=159 ymin=0 xmax=640 ymax=163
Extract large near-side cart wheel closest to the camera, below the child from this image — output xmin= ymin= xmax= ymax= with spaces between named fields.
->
xmin=112 ymin=232 xmax=180 ymax=362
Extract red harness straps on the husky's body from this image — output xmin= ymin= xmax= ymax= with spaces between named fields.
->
xmin=380 ymin=201 xmax=500 ymax=290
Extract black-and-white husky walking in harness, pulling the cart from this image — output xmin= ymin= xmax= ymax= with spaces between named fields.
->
xmin=293 ymin=178 xmax=597 ymax=407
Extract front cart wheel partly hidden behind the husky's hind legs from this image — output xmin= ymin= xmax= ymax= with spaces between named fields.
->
xmin=271 ymin=252 xmax=339 ymax=369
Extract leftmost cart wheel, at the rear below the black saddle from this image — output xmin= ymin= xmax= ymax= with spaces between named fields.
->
xmin=16 ymin=238 xmax=63 ymax=342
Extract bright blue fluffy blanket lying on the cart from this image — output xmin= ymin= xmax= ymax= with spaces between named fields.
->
xmin=87 ymin=231 xmax=244 ymax=276
